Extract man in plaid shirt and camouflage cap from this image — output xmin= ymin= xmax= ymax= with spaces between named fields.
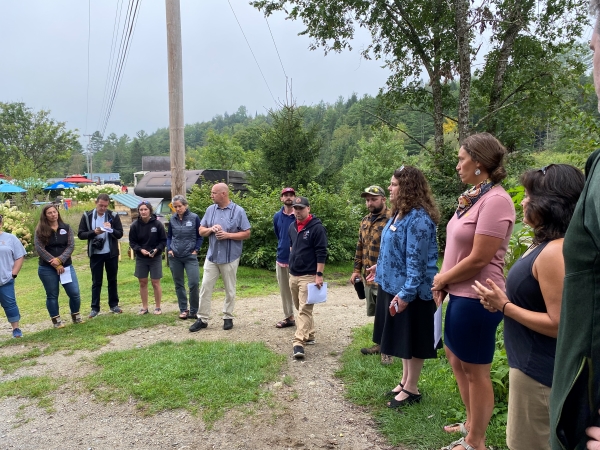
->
xmin=350 ymin=185 xmax=393 ymax=364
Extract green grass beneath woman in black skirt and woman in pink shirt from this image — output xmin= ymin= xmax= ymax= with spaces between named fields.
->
xmin=336 ymin=325 xmax=506 ymax=449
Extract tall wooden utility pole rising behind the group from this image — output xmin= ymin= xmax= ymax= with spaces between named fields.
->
xmin=165 ymin=0 xmax=185 ymax=197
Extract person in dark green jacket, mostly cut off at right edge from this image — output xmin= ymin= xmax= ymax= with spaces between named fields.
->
xmin=552 ymin=0 xmax=600 ymax=450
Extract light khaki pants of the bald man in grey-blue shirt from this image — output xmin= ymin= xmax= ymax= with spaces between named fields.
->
xmin=198 ymin=258 xmax=240 ymax=322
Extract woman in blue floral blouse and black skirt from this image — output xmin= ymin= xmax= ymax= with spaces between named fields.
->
xmin=369 ymin=166 xmax=441 ymax=408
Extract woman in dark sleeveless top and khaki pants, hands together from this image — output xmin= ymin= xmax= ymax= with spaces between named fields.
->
xmin=474 ymin=164 xmax=584 ymax=450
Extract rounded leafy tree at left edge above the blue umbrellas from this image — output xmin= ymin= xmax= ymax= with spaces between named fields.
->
xmin=0 ymin=102 xmax=79 ymax=175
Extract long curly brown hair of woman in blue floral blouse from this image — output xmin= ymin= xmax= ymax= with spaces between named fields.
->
xmin=394 ymin=166 xmax=440 ymax=224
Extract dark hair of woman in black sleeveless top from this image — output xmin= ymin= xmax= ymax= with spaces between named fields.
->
xmin=521 ymin=164 xmax=585 ymax=244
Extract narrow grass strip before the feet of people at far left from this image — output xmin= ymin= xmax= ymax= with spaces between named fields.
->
xmin=0 ymin=313 xmax=177 ymax=356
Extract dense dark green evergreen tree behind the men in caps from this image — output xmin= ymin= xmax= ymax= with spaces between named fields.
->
xmin=251 ymin=104 xmax=322 ymax=187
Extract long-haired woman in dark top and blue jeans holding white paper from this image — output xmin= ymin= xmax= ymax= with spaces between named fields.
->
xmin=34 ymin=205 xmax=83 ymax=328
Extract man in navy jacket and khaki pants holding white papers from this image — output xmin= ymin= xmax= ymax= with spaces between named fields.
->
xmin=289 ymin=197 xmax=327 ymax=359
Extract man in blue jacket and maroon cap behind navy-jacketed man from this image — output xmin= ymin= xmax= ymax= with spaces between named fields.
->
xmin=273 ymin=187 xmax=296 ymax=328
